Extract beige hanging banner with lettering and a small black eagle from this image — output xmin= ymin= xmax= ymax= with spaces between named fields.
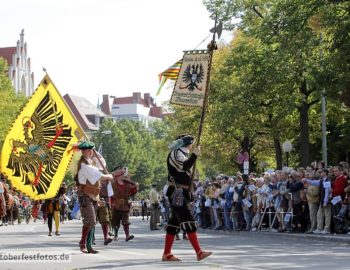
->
xmin=170 ymin=51 xmax=210 ymax=107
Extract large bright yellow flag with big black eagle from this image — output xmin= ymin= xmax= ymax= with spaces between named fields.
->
xmin=0 ymin=75 xmax=84 ymax=200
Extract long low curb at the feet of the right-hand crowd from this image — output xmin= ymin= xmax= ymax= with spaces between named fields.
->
xmin=198 ymin=228 xmax=350 ymax=245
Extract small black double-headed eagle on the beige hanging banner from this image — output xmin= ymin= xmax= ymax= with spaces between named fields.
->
xmin=180 ymin=64 xmax=204 ymax=91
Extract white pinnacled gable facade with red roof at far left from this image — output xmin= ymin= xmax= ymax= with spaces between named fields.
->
xmin=0 ymin=30 xmax=34 ymax=97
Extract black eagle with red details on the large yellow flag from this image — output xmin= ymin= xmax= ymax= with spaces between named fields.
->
xmin=7 ymin=92 xmax=72 ymax=195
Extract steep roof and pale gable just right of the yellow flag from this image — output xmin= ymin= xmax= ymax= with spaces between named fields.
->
xmin=63 ymin=94 xmax=106 ymax=130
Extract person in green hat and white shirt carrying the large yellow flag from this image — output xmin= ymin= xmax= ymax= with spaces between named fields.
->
xmin=75 ymin=141 xmax=113 ymax=254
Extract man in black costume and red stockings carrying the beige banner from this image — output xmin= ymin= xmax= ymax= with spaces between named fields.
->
xmin=162 ymin=135 xmax=212 ymax=261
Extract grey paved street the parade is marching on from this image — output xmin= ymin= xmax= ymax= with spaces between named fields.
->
xmin=0 ymin=218 xmax=350 ymax=270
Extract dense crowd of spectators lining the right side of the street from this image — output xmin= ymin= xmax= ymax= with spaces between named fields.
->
xmin=161 ymin=162 xmax=350 ymax=234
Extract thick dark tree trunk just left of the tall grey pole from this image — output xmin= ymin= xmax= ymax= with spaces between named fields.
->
xmin=299 ymin=80 xmax=310 ymax=168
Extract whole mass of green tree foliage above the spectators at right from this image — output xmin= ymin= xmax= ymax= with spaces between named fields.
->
xmin=171 ymin=0 xmax=350 ymax=174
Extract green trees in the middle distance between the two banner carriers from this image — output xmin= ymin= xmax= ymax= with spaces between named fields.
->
xmin=94 ymin=120 xmax=168 ymax=191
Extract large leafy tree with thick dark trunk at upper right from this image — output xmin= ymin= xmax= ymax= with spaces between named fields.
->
xmin=204 ymin=0 xmax=350 ymax=169
